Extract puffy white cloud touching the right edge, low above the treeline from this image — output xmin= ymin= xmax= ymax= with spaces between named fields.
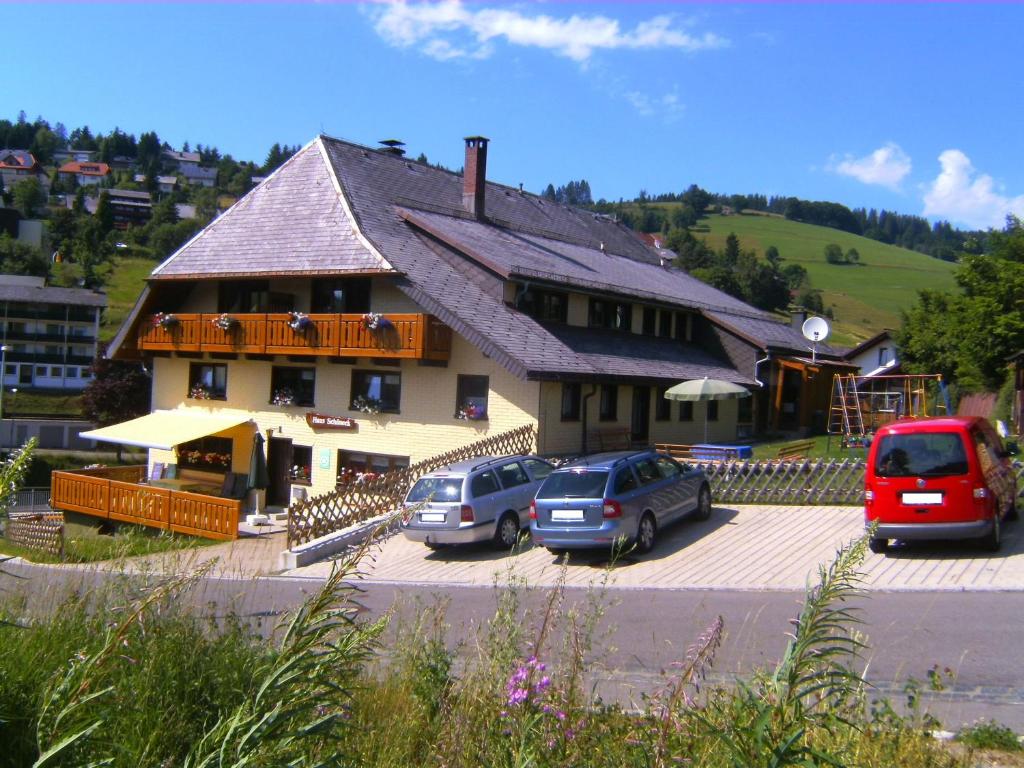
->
xmin=924 ymin=150 xmax=1024 ymax=228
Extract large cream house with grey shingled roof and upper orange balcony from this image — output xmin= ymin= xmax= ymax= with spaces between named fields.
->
xmin=92 ymin=136 xmax=843 ymax=512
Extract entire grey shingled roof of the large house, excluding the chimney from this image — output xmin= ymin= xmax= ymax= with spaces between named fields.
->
xmin=146 ymin=136 xmax=831 ymax=384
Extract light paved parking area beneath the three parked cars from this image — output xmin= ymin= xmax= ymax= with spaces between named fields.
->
xmin=288 ymin=505 xmax=1024 ymax=591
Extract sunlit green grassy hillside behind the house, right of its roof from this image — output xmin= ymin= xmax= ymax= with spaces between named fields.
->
xmin=692 ymin=214 xmax=955 ymax=344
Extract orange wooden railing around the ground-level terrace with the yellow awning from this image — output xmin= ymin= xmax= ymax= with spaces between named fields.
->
xmin=50 ymin=466 xmax=242 ymax=540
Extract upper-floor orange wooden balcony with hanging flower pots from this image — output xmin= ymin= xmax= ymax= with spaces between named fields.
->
xmin=138 ymin=312 xmax=452 ymax=360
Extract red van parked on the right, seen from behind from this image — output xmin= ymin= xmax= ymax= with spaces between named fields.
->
xmin=864 ymin=416 xmax=1017 ymax=552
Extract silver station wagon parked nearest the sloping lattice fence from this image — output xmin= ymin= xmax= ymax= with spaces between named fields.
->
xmin=401 ymin=456 xmax=554 ymax=549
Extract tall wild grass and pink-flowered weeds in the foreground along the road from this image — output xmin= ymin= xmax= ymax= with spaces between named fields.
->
xmin=0 ymin=528 xmax=999 ymax=768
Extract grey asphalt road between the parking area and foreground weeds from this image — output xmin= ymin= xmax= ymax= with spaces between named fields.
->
xmin=6 ymin=562 xmax=1024 ymax=731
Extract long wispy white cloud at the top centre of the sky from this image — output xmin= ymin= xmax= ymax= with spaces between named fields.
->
xmin=369 ymin=0 xmax=728 ymax=63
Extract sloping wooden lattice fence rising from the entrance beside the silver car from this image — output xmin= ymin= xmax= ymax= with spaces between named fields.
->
xmin=288 ymin=424 xmax=537 ymax=547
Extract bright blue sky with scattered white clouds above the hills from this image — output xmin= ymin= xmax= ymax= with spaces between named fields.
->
xmin=0 ymin=0 xmax=1024 ymax=228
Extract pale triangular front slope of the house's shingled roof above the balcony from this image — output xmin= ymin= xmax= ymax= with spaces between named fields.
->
xmin=152 ymin=143 xmax=391 ymax=279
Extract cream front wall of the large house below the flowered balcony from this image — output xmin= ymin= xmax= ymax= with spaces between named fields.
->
xmin=151 ymin=331 xmax=540 ymax=495
